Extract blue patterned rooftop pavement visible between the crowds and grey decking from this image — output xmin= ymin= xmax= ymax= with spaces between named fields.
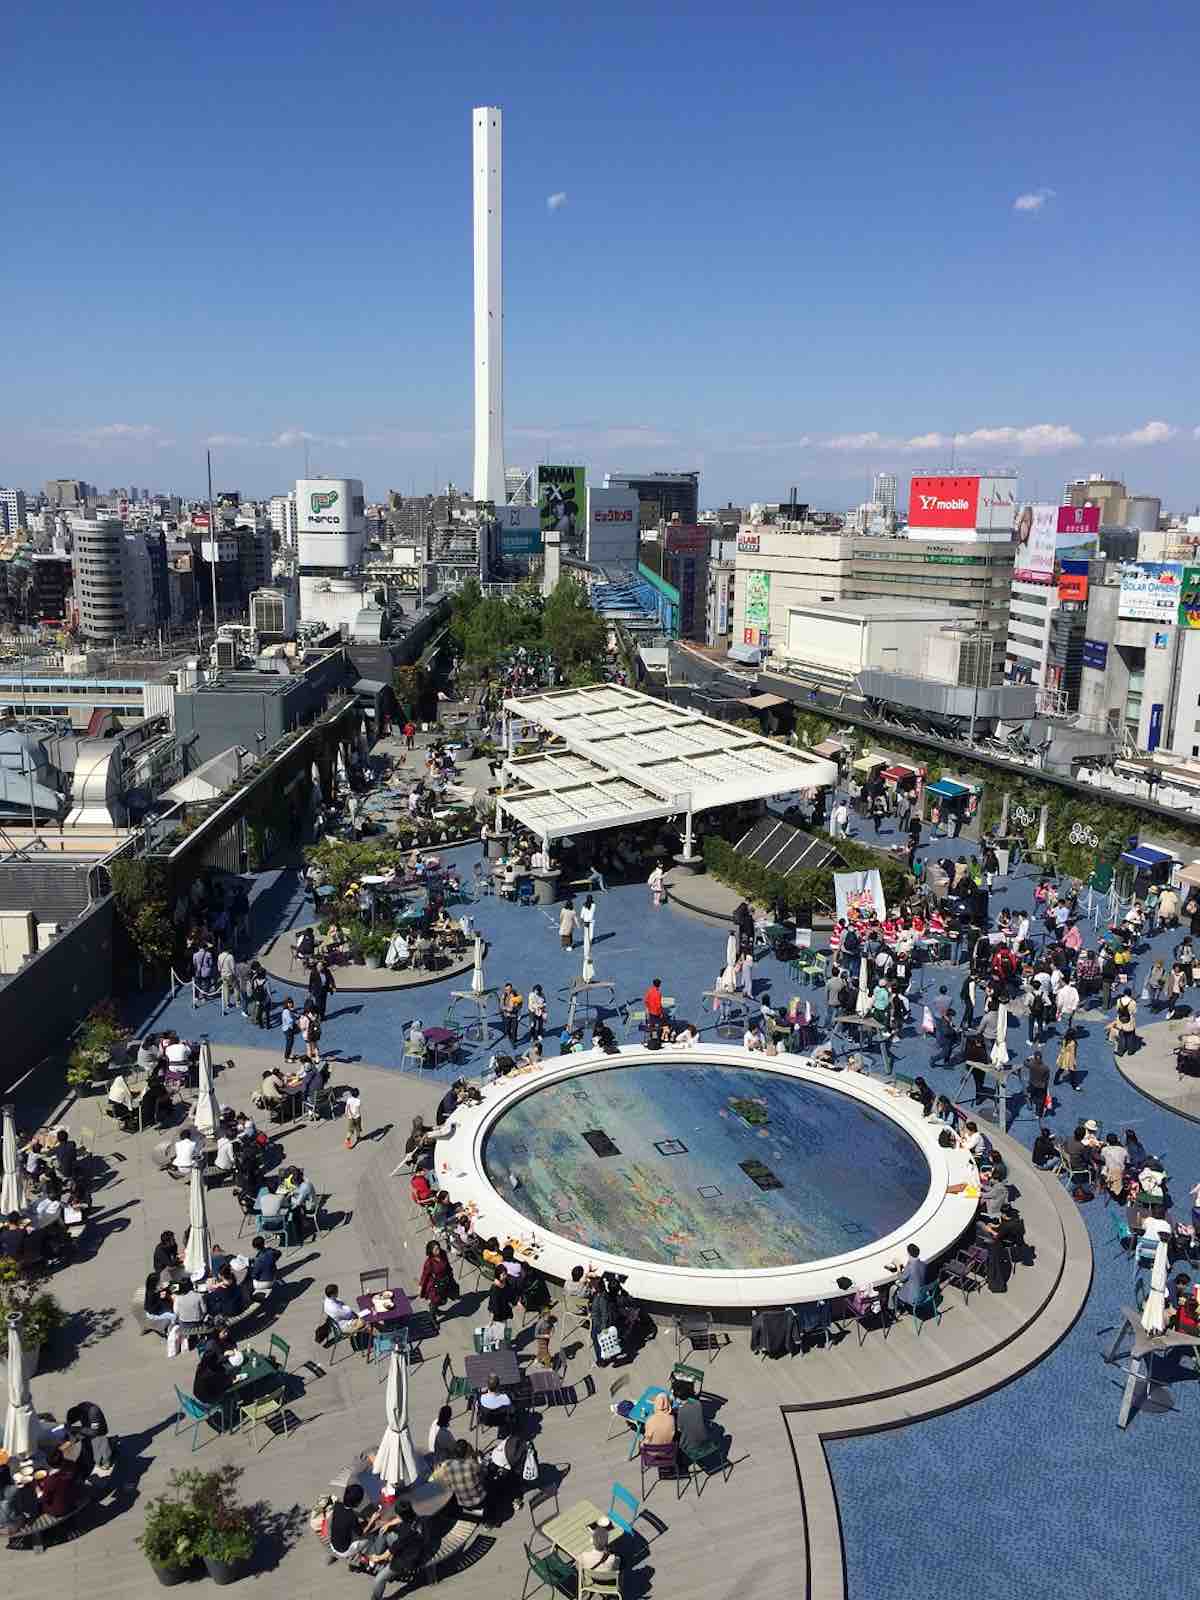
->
xmin=124 ymin=829 xmax=1200 ymax=1600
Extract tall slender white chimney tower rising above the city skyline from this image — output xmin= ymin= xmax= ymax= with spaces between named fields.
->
xmin=470 ymin=106 xmax=504 ymax=506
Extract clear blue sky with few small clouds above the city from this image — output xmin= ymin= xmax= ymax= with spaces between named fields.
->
xmin=0 ymin=0 xmax=1200 ymax=507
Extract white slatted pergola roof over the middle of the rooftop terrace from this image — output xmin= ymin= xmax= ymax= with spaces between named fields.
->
xmin=496 ymin=685 xmax=837 ymax=856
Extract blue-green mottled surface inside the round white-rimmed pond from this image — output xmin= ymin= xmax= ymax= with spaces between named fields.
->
xmin=483 ymin=1062 xmax=930 ymax=1270
